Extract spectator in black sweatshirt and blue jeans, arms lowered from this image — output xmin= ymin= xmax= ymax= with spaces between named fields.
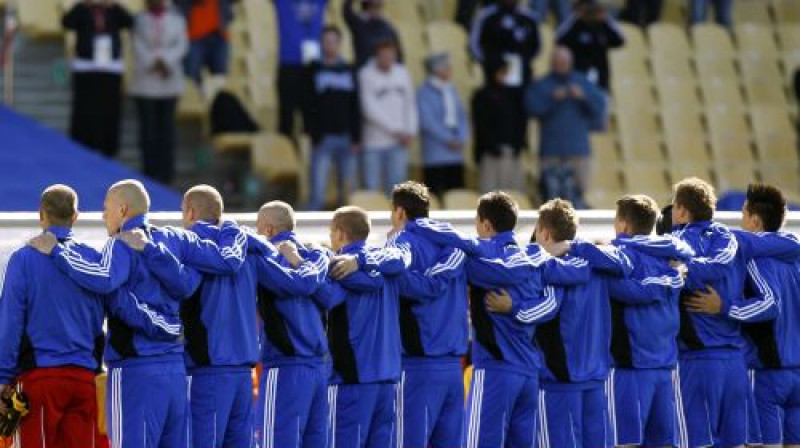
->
xmin=303 ymin=26 xmax=361 ymax=211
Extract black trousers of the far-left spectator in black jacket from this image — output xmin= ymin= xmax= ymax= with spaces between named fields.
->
xmin=69 ymin=72 xmax=122 ymax=157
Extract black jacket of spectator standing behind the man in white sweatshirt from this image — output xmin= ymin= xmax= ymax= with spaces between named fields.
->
xmin=342 ymin=0 xmax=406 ymax=68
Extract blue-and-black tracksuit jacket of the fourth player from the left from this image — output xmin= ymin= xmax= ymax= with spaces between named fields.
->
xmin=258 ymin=232 xmax=328 ymax=367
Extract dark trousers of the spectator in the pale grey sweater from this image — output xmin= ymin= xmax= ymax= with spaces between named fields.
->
xmin=136 ymin=98 xmax=178 ymax=184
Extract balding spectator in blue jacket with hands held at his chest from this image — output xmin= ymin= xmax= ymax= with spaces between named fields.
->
xmin=526 ymin=47 xmax=606 ymax=207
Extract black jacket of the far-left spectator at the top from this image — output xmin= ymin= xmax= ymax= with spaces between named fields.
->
xmin=61 ymin=0 xmax=133 ymax=60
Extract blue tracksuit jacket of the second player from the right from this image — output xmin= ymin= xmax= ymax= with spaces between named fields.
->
xmin=673 ymin=221 xmax=798 ymax=357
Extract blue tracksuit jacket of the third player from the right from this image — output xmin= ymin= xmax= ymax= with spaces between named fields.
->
xmin=609 ymin=235 xmax=694 ymax=369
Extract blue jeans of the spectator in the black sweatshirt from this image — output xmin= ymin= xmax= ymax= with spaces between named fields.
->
xmin=308 ymin=135 xmax=355 ymax=211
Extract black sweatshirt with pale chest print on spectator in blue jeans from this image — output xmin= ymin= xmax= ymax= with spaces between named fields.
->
xmin=303 ymin=61 xmax=361 ymax=144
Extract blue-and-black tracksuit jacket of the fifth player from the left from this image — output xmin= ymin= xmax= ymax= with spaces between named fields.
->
xmin=316 ymin=241 xmax=404 ymax=384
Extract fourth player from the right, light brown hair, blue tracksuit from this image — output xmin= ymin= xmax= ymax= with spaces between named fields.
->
xmin=535 ymin=199 xmax=633 ymax=448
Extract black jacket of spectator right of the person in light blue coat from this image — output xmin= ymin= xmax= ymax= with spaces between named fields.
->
xmin=472 ymin=84 xmax=522 ymax=163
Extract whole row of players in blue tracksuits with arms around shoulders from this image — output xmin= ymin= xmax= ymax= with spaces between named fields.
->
xmin=0 ymin=179 xmax=800 ymax=448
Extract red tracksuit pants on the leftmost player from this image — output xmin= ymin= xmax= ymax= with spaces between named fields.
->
xmin=19 ymin=367 xmax=101 ymax=448
